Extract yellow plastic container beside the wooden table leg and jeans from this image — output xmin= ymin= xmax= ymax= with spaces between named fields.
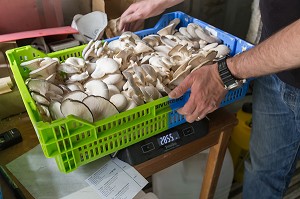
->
xmin=228 ymin=104 xmax=252 ymax=182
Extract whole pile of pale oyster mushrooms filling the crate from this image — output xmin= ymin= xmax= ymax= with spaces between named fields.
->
xmin=21 ymin=18 xmax=230 ymax=122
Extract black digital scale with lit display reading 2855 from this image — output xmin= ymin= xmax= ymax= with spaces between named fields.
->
xmin=116 ymin=118 xmax=208 ymax=166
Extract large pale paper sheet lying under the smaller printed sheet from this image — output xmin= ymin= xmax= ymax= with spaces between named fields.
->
xmin=6 ymin=145 xmax=110 ymax=199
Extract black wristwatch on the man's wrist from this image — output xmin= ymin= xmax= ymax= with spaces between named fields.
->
xmin=217 ymin=57 xmax=246 ymax=90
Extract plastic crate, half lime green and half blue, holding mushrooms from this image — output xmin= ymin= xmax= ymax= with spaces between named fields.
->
xmin=6 ymin=12 xmax=251 ymax=173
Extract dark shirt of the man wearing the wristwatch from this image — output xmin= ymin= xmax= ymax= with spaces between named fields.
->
xmin=260 ymin=0 xmax=300 ymax=88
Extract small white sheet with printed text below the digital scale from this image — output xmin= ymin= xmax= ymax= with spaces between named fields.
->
xmin=86 ymin=158 xmax=148 ymax=199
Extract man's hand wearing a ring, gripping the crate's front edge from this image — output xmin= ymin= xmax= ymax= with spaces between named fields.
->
xmin=169 ymin=64 xmax=227 ymax=123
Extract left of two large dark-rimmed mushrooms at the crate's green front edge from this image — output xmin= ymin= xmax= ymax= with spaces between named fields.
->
xmin=60 ymin=99 xmax=94 ymax=122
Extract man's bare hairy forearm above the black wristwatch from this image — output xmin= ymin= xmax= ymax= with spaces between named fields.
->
xmin=227 ymin=20 xmax=300 ymax=79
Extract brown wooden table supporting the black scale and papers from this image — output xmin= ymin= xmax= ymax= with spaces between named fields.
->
xmin=0 ymin=108 xmax=237 ymax=199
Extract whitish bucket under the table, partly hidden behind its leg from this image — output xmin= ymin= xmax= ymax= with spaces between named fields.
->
xmin=152 ymin=150 xmax=234 ymax=199
